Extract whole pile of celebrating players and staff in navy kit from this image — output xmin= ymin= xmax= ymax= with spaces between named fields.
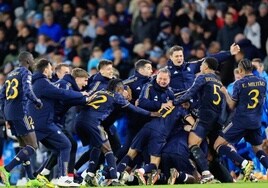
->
xmin=0 ymin=45 xmax=268 ymax=187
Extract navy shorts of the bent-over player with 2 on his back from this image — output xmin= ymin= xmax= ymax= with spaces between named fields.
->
xmin=75 ymin=121 xmax=108 ymax=148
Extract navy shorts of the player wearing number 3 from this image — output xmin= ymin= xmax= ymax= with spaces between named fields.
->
xmin=220 ymin=122 xmax=263 ymax=146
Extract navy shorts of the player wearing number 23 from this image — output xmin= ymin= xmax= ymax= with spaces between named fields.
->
xmin=8 ymin=116 xmax=34 ymax=136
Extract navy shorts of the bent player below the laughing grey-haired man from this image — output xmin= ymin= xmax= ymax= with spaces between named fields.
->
xmin=130 ymin=127 xmax=167 ymax=156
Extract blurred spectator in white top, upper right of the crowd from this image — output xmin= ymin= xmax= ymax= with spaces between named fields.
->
xmin=244 ymin=13 xmax=261 ymax=49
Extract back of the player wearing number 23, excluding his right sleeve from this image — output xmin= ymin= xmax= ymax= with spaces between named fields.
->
xmin=4 ymin=67 xmax=28 ymax=120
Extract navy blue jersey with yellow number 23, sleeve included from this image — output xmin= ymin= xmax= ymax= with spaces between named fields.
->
xmin=1 ymin=67 xmax=38 ymax=120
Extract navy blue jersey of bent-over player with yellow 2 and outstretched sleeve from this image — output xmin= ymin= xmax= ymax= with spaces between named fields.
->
xmin=78 ymin=90 xmax=150 ymax=125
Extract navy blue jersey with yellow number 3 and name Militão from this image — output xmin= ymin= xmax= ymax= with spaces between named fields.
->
xmin=232 ymin=75 xmax=267 ymax=129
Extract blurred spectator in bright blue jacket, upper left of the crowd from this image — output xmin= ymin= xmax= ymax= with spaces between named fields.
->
xmin=38 ymin=11 xmax=63 ymax=42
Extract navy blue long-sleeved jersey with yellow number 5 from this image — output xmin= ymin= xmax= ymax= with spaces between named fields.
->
xmin=175 ymin=73 xmax=223 ymax=115
